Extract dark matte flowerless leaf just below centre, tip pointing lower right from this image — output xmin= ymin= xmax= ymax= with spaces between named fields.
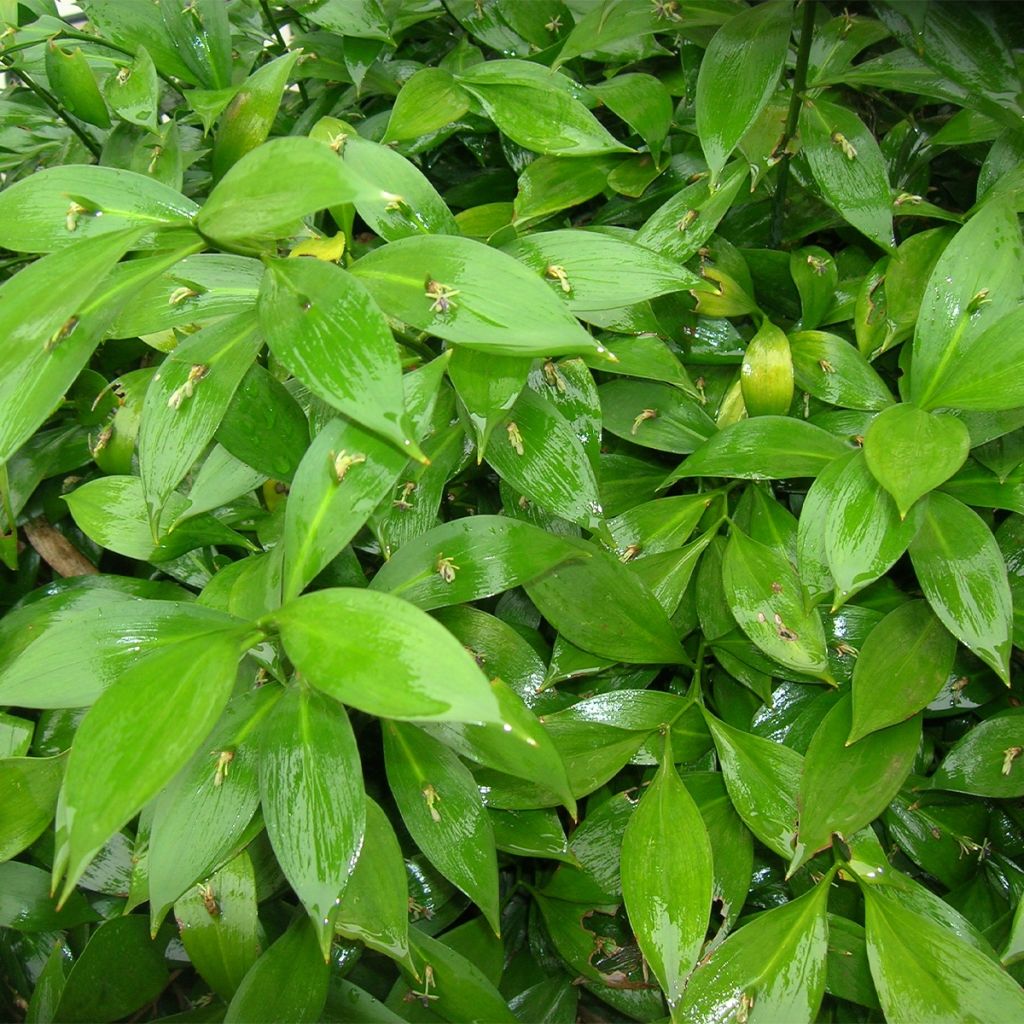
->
xmin=525 ymin=541 xmax=686 ymax=665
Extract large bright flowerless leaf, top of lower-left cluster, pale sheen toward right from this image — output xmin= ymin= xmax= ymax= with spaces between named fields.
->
xmin=267 ymin=589 xmax=501 ymax=723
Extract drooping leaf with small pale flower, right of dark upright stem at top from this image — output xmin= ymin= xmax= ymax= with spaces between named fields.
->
xmin=800 ymin=98 xmax=896 ymax=249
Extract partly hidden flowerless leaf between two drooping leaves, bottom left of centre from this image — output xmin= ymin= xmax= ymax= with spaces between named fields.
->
xmin=334 ymin=797 xmax=410 ymax=963
